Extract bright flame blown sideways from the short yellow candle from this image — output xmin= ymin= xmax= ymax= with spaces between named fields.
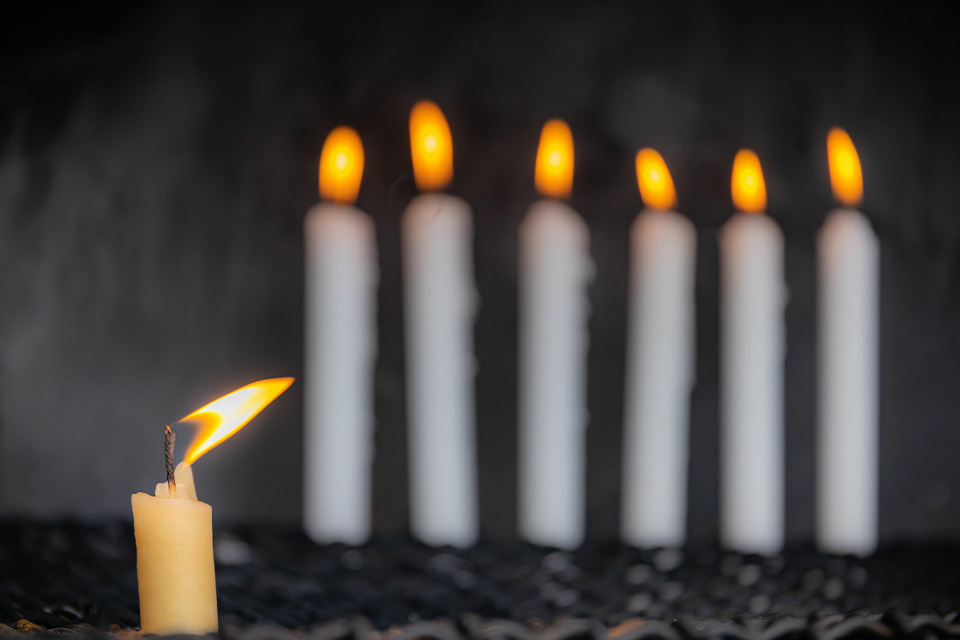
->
xmin=180 ymin=378 xmax=293 ymax=464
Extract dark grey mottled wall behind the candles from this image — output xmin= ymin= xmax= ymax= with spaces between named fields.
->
xmin=0 ymin=1 xmax=960 ymax=541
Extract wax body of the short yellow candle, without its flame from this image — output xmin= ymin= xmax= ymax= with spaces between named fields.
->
xmin=131 ymin=462 xmax=218 ymax=635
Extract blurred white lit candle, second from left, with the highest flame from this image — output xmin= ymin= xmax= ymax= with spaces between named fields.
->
xmin=401 ymin=102 xmax=478 ymax=547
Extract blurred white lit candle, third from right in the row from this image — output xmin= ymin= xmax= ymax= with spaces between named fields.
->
xmin=621 ymin=149 xmax=697 ymax=547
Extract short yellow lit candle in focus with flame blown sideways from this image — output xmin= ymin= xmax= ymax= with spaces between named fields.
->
xmin=131 ymin=378 xmax=293 ymax=635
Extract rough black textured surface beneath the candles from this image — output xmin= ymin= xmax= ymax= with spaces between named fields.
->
xmin=0 ymin=521 xmax=960 ymax=640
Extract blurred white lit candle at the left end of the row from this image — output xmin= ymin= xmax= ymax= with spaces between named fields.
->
xmin=303 ymin=127 xmax=378 ymax=544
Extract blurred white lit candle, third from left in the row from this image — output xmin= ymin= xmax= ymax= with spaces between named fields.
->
xmin=519 ymin=120 xmax=593 ymax=549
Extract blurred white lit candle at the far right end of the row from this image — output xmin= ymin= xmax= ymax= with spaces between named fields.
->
xmin=817 ymin=129 xmax=880 ymax=555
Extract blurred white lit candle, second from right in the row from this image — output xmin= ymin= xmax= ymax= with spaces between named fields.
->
xmin=719 ymin=150 xmax=787 ymax=554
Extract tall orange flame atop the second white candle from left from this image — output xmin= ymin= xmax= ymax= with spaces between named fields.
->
xmin=410 ymin=100 xmax=453 ymax=191
